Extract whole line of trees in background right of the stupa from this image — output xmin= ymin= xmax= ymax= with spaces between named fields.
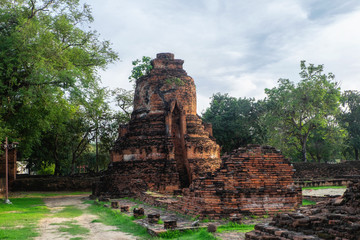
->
xmin=203 ymin=61 xmax=360 ymax=162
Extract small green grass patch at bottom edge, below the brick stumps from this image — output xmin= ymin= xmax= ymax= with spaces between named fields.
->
xmin=156 ymin=229 xmax=216 ymax=240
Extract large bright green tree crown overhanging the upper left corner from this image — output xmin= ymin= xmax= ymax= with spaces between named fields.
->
xmin=0 ymin=0 xmax=118 ymax=159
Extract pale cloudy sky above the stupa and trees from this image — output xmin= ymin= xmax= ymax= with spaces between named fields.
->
xmin=83 ymin=0 xmax=360 ymax=113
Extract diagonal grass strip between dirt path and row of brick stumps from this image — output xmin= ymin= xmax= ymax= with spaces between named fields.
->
xmin=88 ymin=201 xmax=151 ymax=238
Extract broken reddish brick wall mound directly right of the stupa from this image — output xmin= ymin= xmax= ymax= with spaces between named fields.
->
xmin=169 ymin=145 xmax=301 ymax=219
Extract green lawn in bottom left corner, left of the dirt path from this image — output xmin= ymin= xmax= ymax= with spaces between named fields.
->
xmin=0 ymin=198 xmax=49 ymax=239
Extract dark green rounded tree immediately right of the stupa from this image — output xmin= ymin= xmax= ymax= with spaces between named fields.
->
xmin=202 ymin=93 xmax=261 ymax=152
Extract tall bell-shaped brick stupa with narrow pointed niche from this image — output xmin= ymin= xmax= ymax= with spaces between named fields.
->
xmin=94 ymin=53 xmax=221 ymax=196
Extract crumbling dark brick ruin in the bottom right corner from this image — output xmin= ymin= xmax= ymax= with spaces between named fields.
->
xmin=246 ymin=182 xmax=360 ymax=240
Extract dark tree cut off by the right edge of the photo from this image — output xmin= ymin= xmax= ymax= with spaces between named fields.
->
xmin=340 ymin=91 xmax=360 ymax=160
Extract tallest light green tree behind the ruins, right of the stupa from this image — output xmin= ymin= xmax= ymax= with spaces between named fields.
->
xmin=265 ymin=61 xmax=340 ymax=162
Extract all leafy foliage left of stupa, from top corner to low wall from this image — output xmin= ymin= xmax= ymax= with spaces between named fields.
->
xmin=0 ymin=0 xmax=124 ymax=174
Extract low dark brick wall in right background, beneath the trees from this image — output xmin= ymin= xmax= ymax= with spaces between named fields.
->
xmin=293 ymin=161 xmax=360 ymax=180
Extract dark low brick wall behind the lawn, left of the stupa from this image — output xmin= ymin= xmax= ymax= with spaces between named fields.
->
xmin=10 ymin=175 xmax=100 ymax=191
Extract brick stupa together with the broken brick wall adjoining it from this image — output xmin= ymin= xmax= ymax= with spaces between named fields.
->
xmin=93 ymin=53 xmax=301 ymax=218
